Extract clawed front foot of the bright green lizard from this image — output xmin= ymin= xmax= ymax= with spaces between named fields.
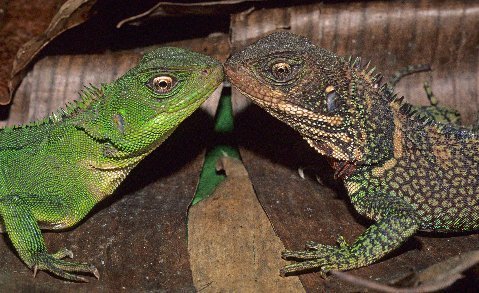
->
xmin=32 ymin=248 xmax=100 ymax=283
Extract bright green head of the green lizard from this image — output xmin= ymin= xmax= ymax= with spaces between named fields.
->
xmin=80 ymin=47 xmax=223 ymax=156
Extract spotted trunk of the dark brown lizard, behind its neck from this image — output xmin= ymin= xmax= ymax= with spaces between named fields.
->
xmin=345 ymin=103 xmax=479 ymax=231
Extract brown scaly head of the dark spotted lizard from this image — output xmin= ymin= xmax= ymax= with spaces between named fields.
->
xmin=225 ymin=32 xmax=386 ymax=162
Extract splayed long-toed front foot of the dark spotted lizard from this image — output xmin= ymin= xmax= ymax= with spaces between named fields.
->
xmin=280 ymin=236 xmax=354 ymax=277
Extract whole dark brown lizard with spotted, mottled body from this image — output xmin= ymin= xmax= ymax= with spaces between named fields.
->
xmin=225 ymin=32 xmax=479 ymax=275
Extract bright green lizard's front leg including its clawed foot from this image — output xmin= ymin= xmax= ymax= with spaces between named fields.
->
xmin=0 ymin=195 xmax=99 ymax=282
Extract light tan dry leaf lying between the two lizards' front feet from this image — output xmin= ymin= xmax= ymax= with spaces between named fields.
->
xmin=188 ymin=157 xmax=304 ymax=292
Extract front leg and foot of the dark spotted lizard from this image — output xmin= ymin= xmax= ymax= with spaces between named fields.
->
xmin=281 ymin=196 xmax=419 ymax=276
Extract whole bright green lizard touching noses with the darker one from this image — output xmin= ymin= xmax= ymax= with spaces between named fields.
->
xmin=0 ymin=47 xmax=223 ymax=281
